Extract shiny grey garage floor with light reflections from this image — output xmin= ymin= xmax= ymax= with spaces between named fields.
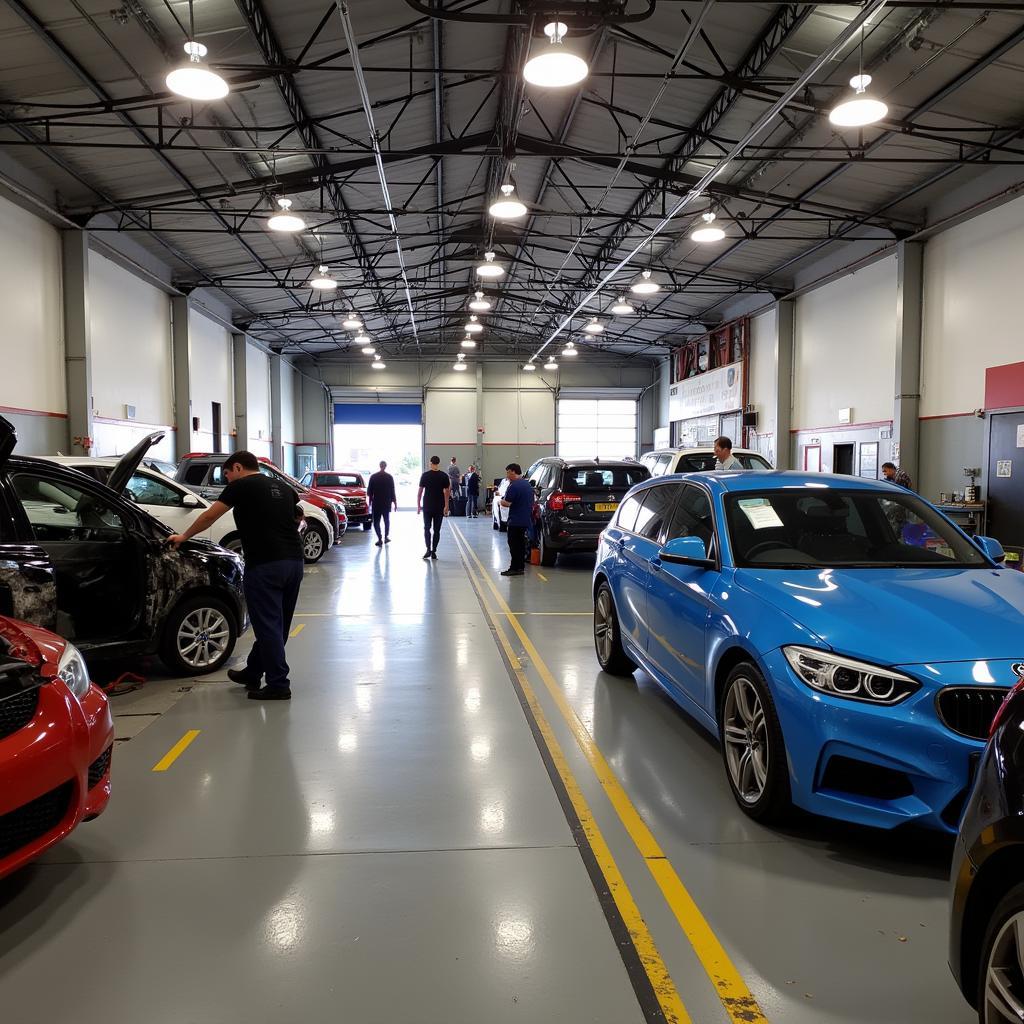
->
xmin=0 ymin=514 xmax=972 ymax=1024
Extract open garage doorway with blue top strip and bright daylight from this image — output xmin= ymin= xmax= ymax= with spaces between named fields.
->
xmin=334 ymin=402 xmax=423 ymax=509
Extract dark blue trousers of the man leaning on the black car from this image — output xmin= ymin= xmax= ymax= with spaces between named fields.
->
xmin=244 ymin=558 xmax=302 ymax=690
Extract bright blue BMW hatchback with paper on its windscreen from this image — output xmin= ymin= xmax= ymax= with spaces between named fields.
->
xmin=594 ymin=472 xmax=1024 ymax=831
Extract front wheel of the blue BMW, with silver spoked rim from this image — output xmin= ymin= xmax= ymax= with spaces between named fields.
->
xmin=719 ymin=662 xmax=793 ymax=824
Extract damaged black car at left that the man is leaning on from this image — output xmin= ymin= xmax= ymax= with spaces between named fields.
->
xmin=0 ymin=417 xmax=248 ymax=675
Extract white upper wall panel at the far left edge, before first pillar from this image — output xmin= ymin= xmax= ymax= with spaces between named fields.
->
xmin=0 ymin=193 xmax=68 ymax=416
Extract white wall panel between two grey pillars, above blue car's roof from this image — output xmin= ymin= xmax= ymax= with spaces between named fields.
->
xmin=793 ymin=256 xmax=896 ymax=429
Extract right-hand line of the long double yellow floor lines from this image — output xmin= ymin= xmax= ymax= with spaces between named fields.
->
xmin=453 ymin=526 xmax=767 ymax=1024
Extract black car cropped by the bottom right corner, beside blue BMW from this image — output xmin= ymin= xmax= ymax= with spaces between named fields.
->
xmin=949 ymin=662 xmax=1024 ymax=1024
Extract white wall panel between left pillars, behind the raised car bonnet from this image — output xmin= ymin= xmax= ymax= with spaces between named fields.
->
xmin=89 ymin=252 xmax=174 ymax=459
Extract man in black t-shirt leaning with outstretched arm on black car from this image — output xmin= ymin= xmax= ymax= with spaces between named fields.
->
xmin=169 ymin=452 xmax=302 ymax=700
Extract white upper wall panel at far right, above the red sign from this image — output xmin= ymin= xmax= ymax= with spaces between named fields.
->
xmin=921 ymin=192 xmax=1024 ymax=417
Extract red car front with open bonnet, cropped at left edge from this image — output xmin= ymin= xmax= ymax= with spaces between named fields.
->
xmin=0 ymin=615 xmax=114 ymax=878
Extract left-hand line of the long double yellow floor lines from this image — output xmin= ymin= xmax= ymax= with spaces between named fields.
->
xmin=456 ymin=530 xmax=691 ymax=1024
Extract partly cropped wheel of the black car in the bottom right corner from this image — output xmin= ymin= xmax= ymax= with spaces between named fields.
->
xmin=978 ymin=884 xmax=1024 ymax=1024
